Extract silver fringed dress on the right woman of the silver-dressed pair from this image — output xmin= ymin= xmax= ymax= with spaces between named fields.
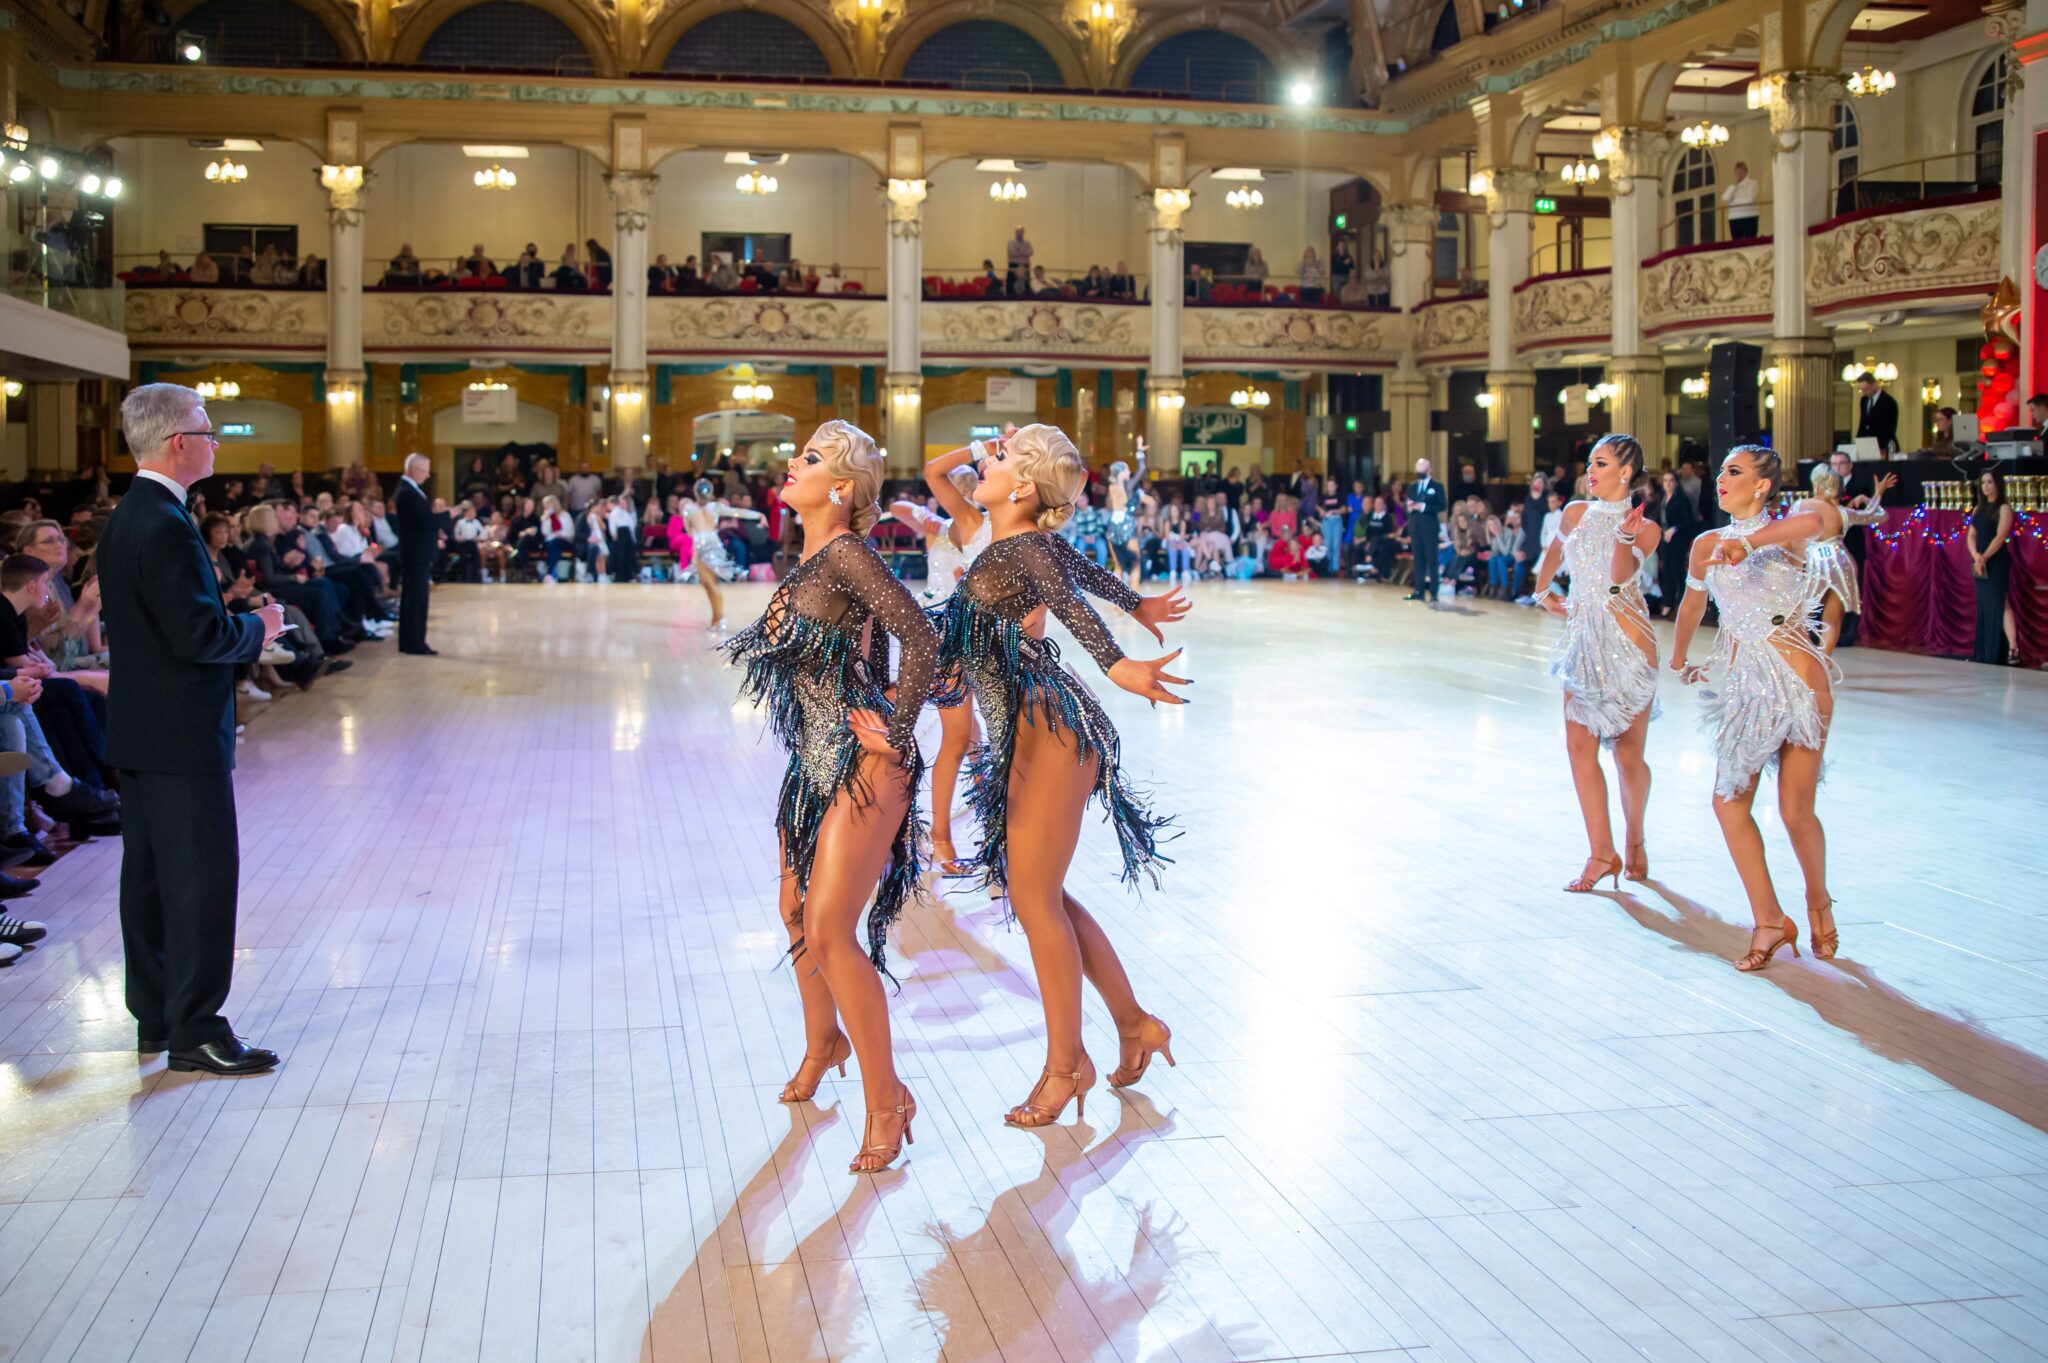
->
xmin=1688 ymin=516 xmax=1837 ymax=800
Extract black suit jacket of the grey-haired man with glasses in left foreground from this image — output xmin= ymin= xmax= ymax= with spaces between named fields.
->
xmin=98 ymin=479 xmax=262 ymax=774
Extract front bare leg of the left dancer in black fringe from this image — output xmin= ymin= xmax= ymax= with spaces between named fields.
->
xmin=803 ymin=755 xmax=911 ymax=1144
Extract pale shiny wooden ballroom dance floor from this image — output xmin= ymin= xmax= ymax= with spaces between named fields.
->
xmin=0 ymin=583 xmax=2048 ymax=1363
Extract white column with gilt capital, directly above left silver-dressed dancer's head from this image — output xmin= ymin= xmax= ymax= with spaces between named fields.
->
xmin=1593 ymin=127 xmax=1671 ymax=448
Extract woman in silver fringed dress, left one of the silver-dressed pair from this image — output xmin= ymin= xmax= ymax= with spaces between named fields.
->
xmin=1536 ymin=436 xmax=1663 ymax=894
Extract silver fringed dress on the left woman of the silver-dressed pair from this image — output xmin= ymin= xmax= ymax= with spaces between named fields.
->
xmin=1550 ymin=501 xmax=1657 ymax=745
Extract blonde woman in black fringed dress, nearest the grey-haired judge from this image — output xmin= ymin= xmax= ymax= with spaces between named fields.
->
xmin=725 ymin=422 xmax=938 ymax=1173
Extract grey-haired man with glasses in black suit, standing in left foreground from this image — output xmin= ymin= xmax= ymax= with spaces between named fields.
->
xmin=98 ymin=383 xmax=285 ymax=1074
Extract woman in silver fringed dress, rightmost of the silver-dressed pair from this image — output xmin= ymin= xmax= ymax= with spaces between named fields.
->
xmin=1671 ymin=444 xmax=1839 ymax=970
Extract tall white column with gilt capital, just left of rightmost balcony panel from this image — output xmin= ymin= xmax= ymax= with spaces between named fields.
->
xmin=1759 ymin=72 xmax=1843 ymax=465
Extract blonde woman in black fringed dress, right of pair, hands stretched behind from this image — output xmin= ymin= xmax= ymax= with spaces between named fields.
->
xmin=940 ymin=426 xmax=1188 ymax=1126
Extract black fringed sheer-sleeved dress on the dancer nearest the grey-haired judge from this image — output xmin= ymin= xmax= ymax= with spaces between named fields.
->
xmin=723 ymin=534 xmax=938 ymax=974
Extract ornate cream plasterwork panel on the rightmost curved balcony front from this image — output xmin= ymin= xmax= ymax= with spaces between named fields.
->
xmin=1806 ymin=199 xmax=1999 ymax=311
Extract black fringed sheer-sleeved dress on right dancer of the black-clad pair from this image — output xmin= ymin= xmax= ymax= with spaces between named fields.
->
xmin=940 ymin=530 xmax=1169 ymax=888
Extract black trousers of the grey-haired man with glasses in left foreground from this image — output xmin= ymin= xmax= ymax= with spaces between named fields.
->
xmin=121 ymin=772 xmax=242 ymax=1050
